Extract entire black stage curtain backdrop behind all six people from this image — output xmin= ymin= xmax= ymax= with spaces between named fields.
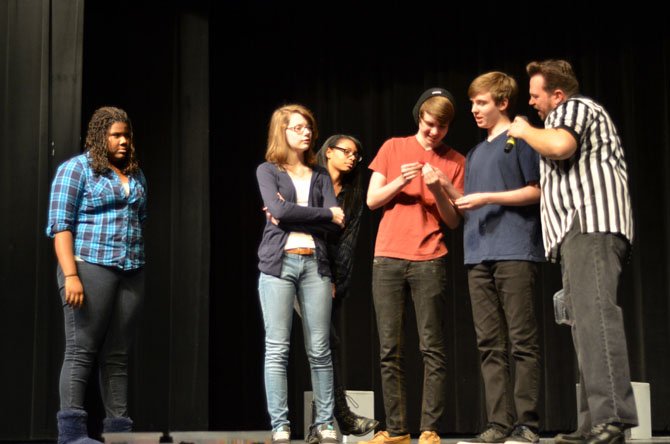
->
xmin=0 ymin=0 xmax=670 ymax=442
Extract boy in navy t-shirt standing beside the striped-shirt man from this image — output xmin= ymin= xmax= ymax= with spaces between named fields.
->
xmin=454 ymin=72 xmax=544 ymax=443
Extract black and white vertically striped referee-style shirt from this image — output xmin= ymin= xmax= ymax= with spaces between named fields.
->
xmin=540 ymin=96 xmax=633 ymax=261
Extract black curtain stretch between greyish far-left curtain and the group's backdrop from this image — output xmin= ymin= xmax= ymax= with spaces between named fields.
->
xmin=82 ymin=1 xmax=210 ymax=438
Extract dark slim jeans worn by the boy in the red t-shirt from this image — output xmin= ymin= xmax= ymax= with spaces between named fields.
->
xmin=372 ymin=257 xmax=447 ymax=435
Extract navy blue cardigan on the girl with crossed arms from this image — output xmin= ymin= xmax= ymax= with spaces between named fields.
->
xmin=256 ymin=162 xmax=340 ymax=277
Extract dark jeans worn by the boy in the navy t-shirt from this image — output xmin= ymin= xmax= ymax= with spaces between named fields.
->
xmin=468 ymin=261 xmax=540 ymax=430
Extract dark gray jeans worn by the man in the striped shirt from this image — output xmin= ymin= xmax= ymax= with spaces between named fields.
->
xmin=560 ymin=224 xmax=638 ymax=430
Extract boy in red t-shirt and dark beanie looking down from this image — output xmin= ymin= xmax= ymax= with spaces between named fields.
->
xmin=364 ymin=88 xmax=465 ymax=444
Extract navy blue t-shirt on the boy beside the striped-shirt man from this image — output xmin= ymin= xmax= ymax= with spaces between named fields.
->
xmin=463 ymin=131 xmax=544 ymax=265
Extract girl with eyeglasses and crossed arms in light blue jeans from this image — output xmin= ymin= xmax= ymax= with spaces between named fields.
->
xmin=256 ymin=104 xmax=344 ymax=444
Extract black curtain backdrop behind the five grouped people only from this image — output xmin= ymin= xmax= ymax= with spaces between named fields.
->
xmin=210 ymin=1 xmax=670 ymax=434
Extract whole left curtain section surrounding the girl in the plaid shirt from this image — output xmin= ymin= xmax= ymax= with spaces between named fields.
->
xmin=0 ymin=0 xmax=210 ymax=442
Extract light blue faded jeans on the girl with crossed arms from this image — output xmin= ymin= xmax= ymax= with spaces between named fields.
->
xmin=258 ymin=254 xmax=334 ymax=430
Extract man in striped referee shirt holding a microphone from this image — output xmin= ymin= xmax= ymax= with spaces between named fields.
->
xmin=509 ymin=60 xmax=637 ymax=444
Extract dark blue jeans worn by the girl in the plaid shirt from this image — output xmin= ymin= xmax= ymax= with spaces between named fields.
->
xmin=56 ymin=261 xmax=144 ymax=418
